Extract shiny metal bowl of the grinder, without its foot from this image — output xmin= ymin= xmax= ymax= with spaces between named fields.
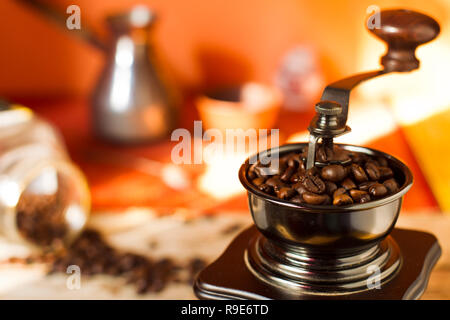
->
xmin=239 ymin=143 xmax=413 ymax=254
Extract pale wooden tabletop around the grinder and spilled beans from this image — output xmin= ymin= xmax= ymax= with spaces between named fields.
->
xmin=0 ymin=208 xmax=450 ymax=300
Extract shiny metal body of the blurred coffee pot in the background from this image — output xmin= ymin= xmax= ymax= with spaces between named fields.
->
xmin=92 ymin=6 xmax=177 ymax=143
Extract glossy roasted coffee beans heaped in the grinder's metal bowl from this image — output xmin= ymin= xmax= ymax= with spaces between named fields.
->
xmin=247 ymin=145 xmax=399 ymax=206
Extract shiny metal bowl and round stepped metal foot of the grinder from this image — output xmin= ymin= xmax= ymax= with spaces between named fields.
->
xmin=239 ymin=143 xmax=413 ymax=295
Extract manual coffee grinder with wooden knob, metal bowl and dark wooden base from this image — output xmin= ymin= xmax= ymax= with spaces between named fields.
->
xmin=194 ymin=10 xmax=441 ymax=300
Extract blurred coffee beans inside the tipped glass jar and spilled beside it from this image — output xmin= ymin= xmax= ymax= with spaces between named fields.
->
xmin=11 ymin=182 xmax=206 ymax=294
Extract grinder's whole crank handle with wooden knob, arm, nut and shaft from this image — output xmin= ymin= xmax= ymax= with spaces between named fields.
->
xmin=306 ymin=9 xmax=440 ymax=169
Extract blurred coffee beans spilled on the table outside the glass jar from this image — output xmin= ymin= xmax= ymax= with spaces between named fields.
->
xmin=15 ymin=229 xmax=206 ymax=294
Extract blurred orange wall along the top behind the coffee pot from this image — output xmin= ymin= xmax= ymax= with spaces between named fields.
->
xmin=0 ymin=0 xmax=446 ymax=97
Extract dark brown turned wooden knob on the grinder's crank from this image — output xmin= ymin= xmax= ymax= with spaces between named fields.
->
xmin=369 ymin=9 xmax=440 ymax=72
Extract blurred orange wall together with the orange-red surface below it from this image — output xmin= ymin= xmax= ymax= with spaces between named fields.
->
xmin=0 ymin=0 xmax=442 ymax=215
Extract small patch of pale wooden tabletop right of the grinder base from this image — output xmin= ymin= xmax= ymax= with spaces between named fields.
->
xmin=397 ymin=214 xmax=450 ymax=300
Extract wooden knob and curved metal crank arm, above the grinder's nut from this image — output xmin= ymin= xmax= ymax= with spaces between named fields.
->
xmin=321 ymin=9 xmax=440 ymax=126
